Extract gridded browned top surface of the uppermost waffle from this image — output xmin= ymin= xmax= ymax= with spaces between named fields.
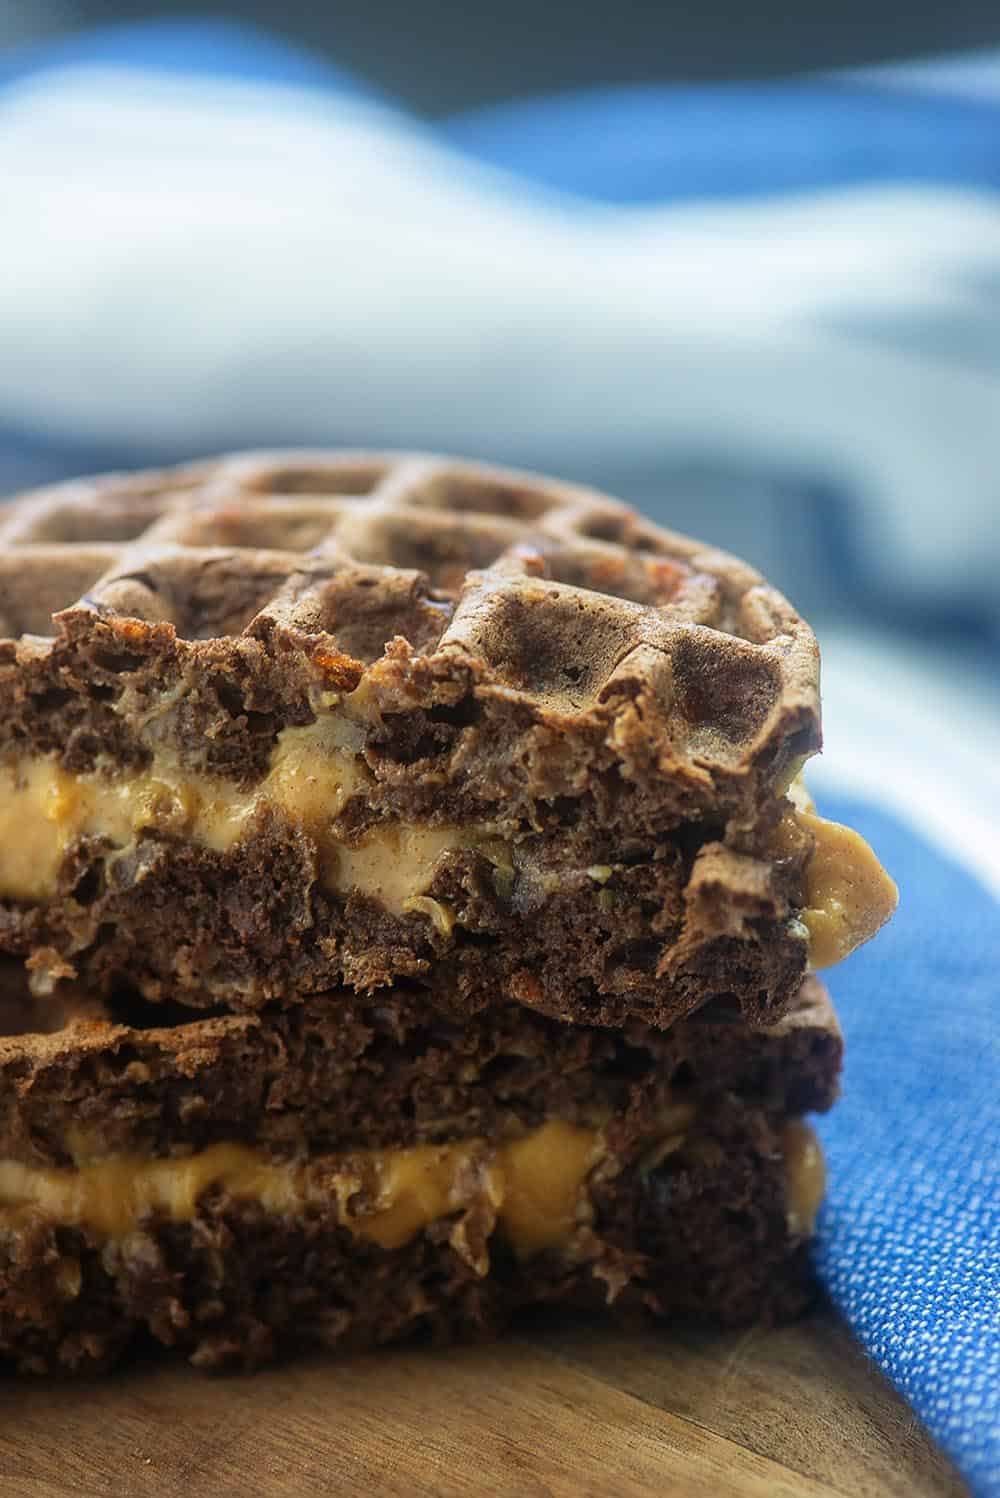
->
xmin=0 ymin=452 xmax=817 ymax=767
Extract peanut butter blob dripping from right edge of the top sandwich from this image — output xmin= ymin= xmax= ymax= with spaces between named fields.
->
xmin=787 ymin=779 xmax=900 ymax=971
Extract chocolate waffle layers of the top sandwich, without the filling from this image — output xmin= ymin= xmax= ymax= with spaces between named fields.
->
xmin=0 ymin=454 xmax=819 ymax=1025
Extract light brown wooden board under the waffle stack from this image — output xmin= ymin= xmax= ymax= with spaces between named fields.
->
xmin=0 ymin=1314 xmax=964 ymax=1498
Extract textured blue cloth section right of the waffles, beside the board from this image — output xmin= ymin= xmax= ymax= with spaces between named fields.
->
xmin=819 ymin=795 xmax=1000 ymax=1498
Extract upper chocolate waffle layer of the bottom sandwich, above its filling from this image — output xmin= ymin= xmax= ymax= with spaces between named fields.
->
xmin=0 ymin=959 xmax=841 ymax=1174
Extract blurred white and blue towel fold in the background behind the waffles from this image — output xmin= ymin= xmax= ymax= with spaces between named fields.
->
xmin=0 ymin=22 xmax=1000 ymax=635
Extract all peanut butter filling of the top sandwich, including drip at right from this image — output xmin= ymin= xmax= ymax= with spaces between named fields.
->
xmin=0 ymin=712 xmax=898 ymax=969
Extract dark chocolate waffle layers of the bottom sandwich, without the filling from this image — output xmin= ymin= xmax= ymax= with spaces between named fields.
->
xmin=0 ymin=980 xmax=841 ymax=1371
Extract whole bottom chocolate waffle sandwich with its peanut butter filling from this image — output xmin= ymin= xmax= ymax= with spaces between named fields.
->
xmin=0 ymin=965 xmax=840 ymax=1372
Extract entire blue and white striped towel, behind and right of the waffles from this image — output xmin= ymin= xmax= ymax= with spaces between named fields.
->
xmin=0 ymin=27 xmax=1000 ymax=1498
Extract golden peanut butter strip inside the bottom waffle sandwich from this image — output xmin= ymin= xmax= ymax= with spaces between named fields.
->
xmin=0 ymin=1119 xmax=605 ymax=1258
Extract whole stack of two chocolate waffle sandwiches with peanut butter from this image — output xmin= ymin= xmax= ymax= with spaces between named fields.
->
xmin=0 ymin=454 xmax=895 ymax=1371
